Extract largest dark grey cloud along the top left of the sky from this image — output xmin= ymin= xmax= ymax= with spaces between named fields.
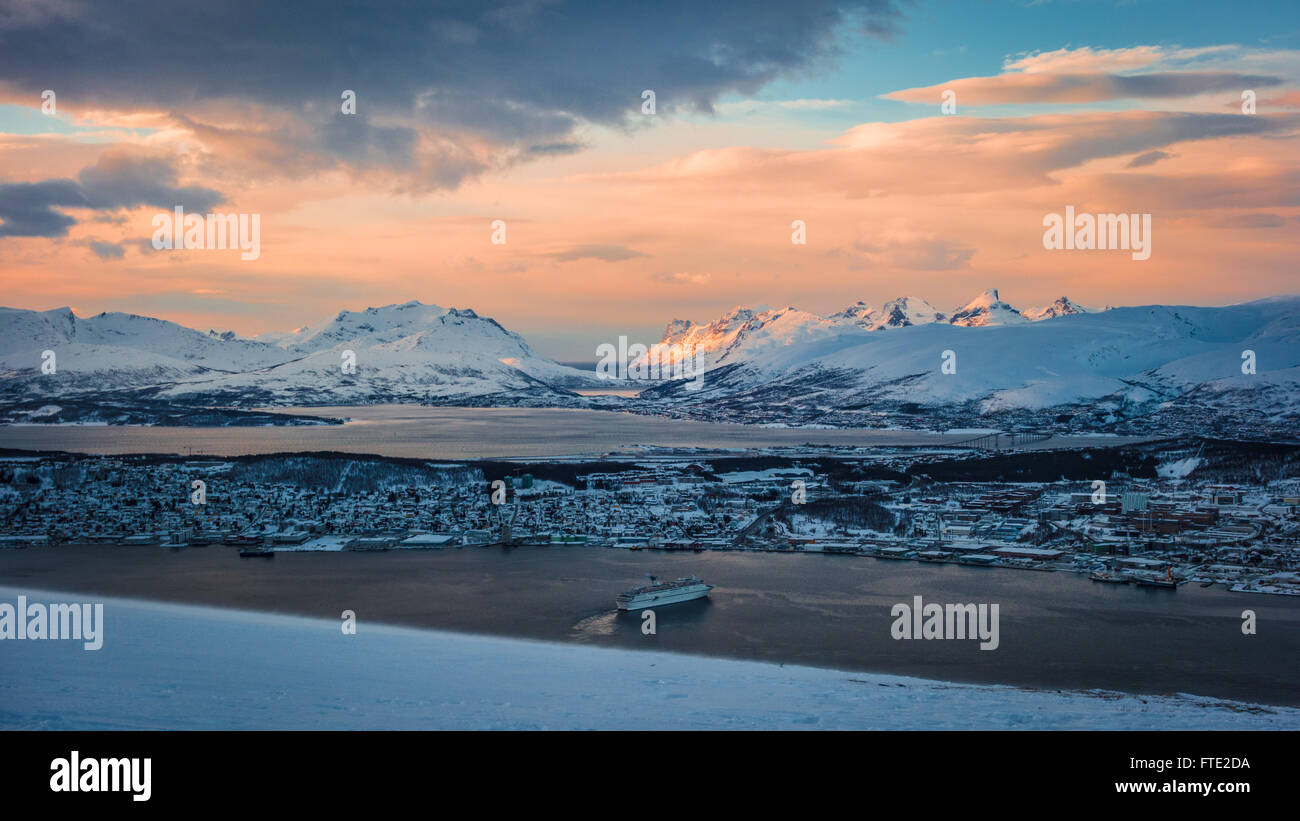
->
xmin=0 ymin=0 xmax=906 ymax=187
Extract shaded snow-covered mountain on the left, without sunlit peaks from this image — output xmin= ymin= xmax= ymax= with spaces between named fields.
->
xmin=0 ymin=301 xmax=608 ymax=407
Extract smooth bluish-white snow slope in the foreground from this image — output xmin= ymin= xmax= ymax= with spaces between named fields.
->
xmin=0 ymin=587 xmax=1300 ymax=730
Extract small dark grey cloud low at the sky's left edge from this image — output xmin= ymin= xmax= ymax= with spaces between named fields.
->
xmin=0 ymin=152 xmax=221 ymax=237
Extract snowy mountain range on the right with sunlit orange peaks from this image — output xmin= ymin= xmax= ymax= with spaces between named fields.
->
xmin=642 ymin=290 xmax=1300 ymax=430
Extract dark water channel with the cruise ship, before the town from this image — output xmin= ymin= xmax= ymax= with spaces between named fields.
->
xmin=0 ymin=547 xmax=1300 ymax=705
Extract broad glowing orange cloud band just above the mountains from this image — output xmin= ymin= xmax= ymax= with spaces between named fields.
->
xmin=0 ymin=102 xmax=1300 ymax=350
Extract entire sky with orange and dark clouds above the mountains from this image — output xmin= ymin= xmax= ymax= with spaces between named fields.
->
xmin=0 ymin=0 xmax=1300 ymax=361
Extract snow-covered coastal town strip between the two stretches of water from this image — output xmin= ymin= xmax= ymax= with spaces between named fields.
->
xmin=0 ymin=443 xmax=1300 ymax=595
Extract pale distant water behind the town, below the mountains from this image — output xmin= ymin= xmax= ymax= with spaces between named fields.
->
xmin=0 ymin=405 xmax=1138 ymax=459
